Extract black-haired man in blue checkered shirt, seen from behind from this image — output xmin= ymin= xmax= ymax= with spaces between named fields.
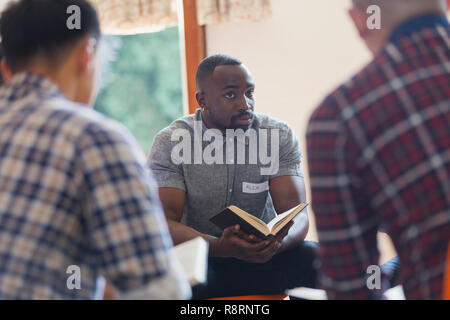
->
xmin=0 ymin=0 xmax=190 ymax=299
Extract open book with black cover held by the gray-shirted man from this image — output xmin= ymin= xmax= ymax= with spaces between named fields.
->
xmin=210 ymin=203 xmax=309 ymax=239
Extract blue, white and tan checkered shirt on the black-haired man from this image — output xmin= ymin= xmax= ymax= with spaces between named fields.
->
xmin=0 ymin=73 xmax=186 ymax=299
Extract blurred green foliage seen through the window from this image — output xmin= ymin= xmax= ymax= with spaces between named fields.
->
xmin=94 ymin=27 xmax=183 ymax=153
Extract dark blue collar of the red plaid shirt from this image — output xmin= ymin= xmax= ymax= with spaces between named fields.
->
xmin=389 ymin=14 xmax=450 ymax=42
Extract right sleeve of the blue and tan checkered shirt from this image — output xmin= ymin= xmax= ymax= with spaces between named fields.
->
xmin=78 ymin=120 xmax=176 ymax=292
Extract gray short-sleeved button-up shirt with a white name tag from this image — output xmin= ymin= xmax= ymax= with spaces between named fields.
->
xmin=149 ymin=109 xmax=303 ymax=236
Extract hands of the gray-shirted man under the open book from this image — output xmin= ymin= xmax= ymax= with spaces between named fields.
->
xmin=217 ymin=225 xmax=281 ymax=263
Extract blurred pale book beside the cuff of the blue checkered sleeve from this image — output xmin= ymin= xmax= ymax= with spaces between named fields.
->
xmin=172 ymin=237 xmax=208 ymax=287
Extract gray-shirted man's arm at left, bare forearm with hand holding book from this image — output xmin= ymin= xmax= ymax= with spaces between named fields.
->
xmin=159 ymin=188 xmax=279 ymax=263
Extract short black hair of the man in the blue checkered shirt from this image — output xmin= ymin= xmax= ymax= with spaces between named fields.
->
xmin=0 ymin=0 xmax=100 ymax=70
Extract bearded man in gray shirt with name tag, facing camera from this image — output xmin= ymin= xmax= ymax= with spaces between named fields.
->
xmin=149 ymin=55 xmax=316 ymax=298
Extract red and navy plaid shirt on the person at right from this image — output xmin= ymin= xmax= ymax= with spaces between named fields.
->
xmin=307 ymin=16 xmax=450 ymax=299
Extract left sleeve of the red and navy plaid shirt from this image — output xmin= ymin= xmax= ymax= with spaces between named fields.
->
xmin=307 ymin=96 xmax=380 ymax=299
